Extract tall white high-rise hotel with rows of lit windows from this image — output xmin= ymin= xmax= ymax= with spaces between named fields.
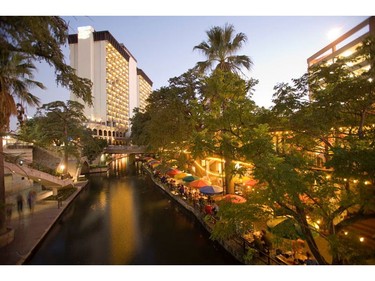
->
xmin=69 ymin=26 xmax=152 ymax=144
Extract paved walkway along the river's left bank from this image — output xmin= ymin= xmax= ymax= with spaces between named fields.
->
xmin=0 ymin=182 xmax=87 ymax=265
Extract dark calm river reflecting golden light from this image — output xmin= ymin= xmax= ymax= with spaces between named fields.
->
xmin=26 ymin=160 xmax=244 ymax=265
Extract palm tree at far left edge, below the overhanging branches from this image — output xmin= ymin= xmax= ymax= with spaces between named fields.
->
xmin=0 ymin=49 xmax=44 ymax=233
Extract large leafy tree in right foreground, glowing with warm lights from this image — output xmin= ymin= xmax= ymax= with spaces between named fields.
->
xmin=212 ymin=36 xmax=375 ymax=264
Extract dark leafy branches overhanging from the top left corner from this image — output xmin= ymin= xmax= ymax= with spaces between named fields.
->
xmin=0 ymin=16 xmax=92 ymax=105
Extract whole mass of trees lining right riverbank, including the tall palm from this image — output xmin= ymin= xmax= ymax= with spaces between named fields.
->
xmin=132 ymin=23 xmax=375 ymax=264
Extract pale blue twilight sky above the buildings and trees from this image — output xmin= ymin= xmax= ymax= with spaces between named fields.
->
xmin=2 ymin=0 xmax=371 ymax=131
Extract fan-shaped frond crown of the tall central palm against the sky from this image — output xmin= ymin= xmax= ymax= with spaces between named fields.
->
xmin=193 ymin=24 xmax=253 ymax=73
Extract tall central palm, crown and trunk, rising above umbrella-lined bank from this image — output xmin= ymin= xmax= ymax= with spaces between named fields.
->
xmin=193 ymin=24 xmax=257 ymax=192
